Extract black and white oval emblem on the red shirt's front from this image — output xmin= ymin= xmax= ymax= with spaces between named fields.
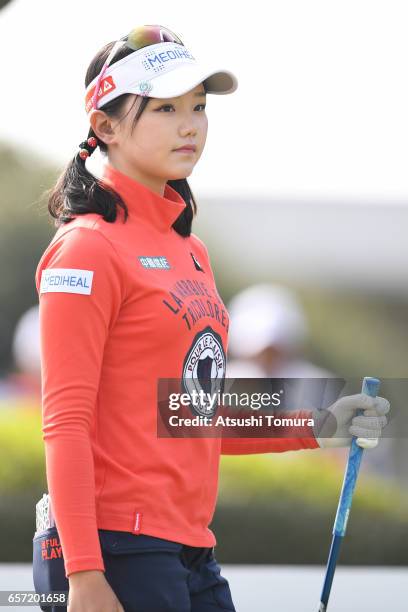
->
xmin=182 ymin=327 xmax=226 ymax=418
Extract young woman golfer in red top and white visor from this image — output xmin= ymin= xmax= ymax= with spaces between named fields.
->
xmin=33 ymin=25 xmax=388 ymax=612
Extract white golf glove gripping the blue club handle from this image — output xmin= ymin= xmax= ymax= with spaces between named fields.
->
xmin=313 ymin=393 xmax=390 ymax=449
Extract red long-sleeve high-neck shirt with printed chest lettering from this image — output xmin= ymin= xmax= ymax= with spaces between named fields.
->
xmin=36 ymin=165 xmax=318 ymax=576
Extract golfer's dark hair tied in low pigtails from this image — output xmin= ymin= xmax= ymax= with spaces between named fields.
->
xmin=46 ymin=42 xmax=197 ymax=236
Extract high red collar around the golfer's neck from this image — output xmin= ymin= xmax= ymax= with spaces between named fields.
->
xmin=101 ymin=164 xmax=186 ymax=231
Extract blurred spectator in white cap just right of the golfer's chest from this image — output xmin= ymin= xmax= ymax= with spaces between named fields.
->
xmin=226 ymin=284 xmax=408 ymax=481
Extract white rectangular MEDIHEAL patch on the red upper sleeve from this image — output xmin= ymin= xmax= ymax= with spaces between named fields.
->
xmin=40 ymin=268 xmax=93 ymax=295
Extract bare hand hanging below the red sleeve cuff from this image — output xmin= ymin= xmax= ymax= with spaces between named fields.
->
xmin=67 ymin=570 xmax=125 ymax=612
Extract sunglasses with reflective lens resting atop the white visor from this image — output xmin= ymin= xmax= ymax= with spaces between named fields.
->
xmin=92 ymin=25 xmax=184 ymax=109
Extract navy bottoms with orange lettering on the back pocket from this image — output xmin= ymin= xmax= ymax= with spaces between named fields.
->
xmin=33 ymin=527 xmax=235 ymax=612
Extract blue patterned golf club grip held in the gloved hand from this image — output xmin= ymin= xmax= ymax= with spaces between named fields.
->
xmin=319 ymin=376 xmax=380 ymax=612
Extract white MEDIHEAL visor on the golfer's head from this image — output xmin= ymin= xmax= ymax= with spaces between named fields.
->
xmin=85 ymin=42 xmax=238 ymax=113
